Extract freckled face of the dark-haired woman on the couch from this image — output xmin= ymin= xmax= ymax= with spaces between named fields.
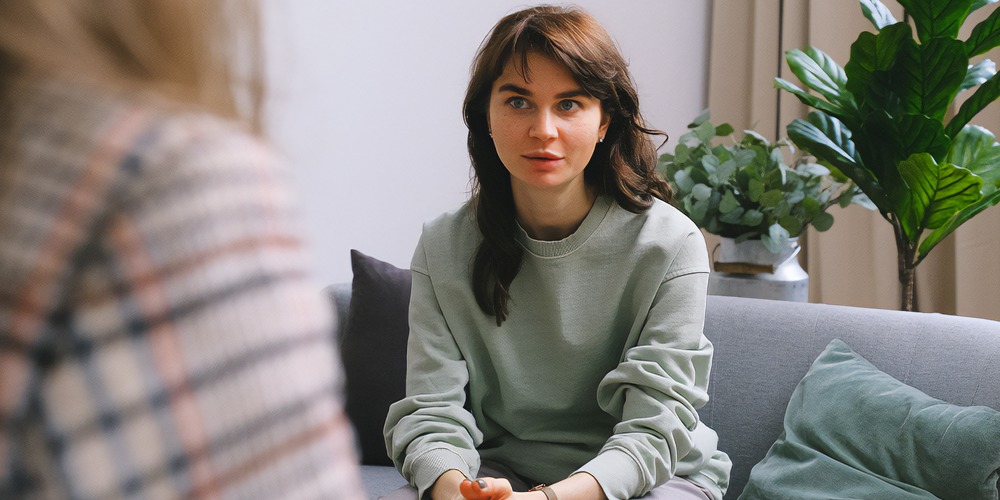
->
xmin=489 ymin=52 xmax=609 ymax=199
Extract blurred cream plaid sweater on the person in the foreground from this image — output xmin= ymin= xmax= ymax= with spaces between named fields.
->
xmin=0 ymin=82 xmax=361 ymax=498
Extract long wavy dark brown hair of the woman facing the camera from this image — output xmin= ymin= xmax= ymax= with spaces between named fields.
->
xmin=463 ymin=6 xmax=671 ymax=326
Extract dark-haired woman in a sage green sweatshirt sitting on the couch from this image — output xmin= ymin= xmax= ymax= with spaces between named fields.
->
xmin=385 ymin=7 xmax=730 ymax=500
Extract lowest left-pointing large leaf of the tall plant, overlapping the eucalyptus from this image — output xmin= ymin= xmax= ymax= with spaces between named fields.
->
xmin=787 ymin=111 xmax=890 ymax=213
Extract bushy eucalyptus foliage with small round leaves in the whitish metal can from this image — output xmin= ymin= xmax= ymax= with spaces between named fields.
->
xmin=658 ymin=111 xmax=863 ymax=253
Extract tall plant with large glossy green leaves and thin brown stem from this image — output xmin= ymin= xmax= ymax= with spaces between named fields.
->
xmin=775 ymin=0 xmax=1000 ymax=310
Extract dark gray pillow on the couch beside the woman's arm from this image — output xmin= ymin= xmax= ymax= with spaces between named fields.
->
xmin=341 ymin=250 xmax=412 ymax=465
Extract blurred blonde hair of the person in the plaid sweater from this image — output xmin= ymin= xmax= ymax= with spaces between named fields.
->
xmin=0 ymin=0 xmax=264 ymax=130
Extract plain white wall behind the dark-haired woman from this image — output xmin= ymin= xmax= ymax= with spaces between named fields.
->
xmin=265 ymin=0 xmax=711 ymax=283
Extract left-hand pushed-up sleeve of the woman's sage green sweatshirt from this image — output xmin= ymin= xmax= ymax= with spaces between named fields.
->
xmin=385 ymin=233 xmax=482 ymax=498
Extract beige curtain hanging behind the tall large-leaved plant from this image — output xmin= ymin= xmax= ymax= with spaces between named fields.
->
xmin=708 ymin=0 xmax=1000 ymax=320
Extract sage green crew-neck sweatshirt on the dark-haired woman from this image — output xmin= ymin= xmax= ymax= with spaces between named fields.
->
xmin=385 ymin=198 xmax=731 ymax=499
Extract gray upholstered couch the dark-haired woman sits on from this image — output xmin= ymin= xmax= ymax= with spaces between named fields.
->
xmin=328 ymin=284 xmax=1000 ymax=499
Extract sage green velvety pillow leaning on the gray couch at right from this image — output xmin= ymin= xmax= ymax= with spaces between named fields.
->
xmin=740 ymin=340 xmax=1000 ymax=500
